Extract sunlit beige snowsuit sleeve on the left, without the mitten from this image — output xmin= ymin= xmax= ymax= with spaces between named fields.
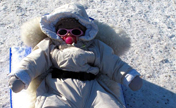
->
xmin=12 ymin=39 xmax=52 ymax=88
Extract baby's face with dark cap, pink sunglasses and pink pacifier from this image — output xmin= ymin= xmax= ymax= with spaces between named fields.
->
xmin=56 ymin=18 xmax=86 ymax=44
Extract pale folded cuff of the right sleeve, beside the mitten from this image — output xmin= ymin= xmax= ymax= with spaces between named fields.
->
xmin=123 ymin=69 xmax=140 ymax=87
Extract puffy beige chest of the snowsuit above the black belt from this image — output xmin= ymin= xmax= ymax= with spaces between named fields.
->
xmin=51 ymin=47 xmax=99 ymax=74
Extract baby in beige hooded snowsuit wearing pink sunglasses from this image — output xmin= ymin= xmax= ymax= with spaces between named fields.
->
xmin=9 ymin=4 xmax=142 ymax=108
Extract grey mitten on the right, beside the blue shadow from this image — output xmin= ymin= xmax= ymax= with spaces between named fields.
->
xmin=129 ymin=76 xmax=143 ymax=91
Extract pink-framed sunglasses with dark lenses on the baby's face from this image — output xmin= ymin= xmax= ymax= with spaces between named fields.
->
xmin=57 ymin=28 xmax=84 ymax=37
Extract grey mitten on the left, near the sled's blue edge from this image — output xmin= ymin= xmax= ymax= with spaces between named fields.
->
xmin=9 ymin=76 xmax=25 ymax=93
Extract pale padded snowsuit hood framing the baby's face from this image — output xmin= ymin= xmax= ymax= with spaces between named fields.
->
xmin=40 ymin=3 xmax=98 ymax=41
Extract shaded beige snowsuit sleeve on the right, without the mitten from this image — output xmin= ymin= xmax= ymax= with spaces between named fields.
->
xmin=90 ymin=40 xmax=139 ymax=87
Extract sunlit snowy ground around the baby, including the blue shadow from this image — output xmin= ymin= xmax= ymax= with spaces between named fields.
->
xmin=0 ymin=0 xmax=176 ymax=108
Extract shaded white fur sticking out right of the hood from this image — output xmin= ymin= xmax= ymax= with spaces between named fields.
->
xmin=95 ymin=20 xmax=131 ymax=56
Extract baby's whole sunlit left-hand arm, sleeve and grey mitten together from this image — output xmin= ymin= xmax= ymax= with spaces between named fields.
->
xmin=9 ymin=38 xmax=52 ymax=92
